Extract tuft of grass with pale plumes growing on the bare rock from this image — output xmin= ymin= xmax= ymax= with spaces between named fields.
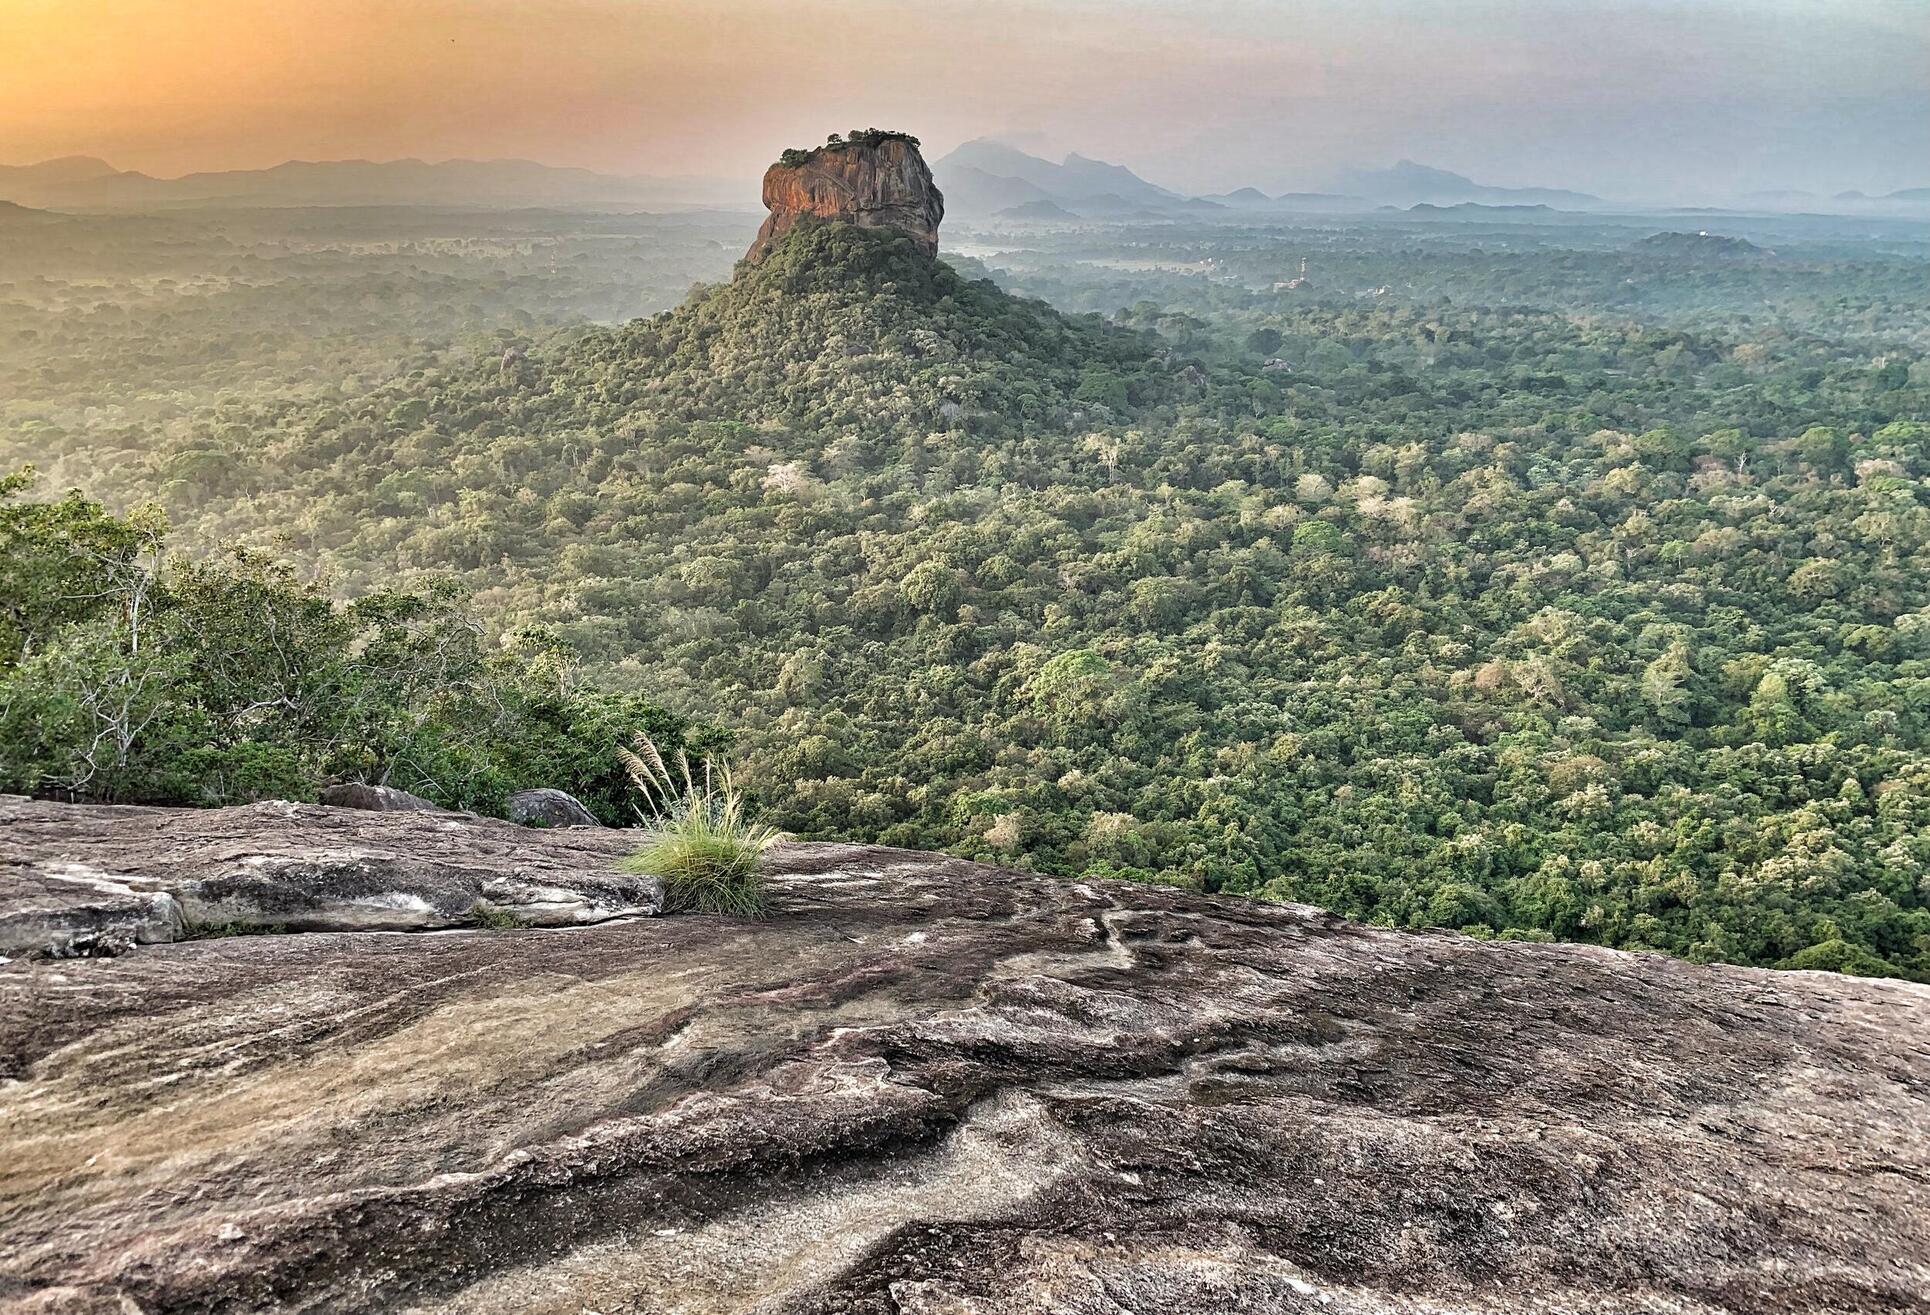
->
xmin=618 ymin=732 xmax=784 ymax=917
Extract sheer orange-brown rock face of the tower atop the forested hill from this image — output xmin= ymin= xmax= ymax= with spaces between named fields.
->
xmin=745 ymin=133 xmax=946 ymax=261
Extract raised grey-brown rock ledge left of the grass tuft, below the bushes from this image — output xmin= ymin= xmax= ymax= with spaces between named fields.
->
xmin=0 ymin=799 xmax=662 ymax=958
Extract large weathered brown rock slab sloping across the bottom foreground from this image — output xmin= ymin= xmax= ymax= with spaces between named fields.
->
xmin=0 ymin=805 xmax=1930 ymax=1315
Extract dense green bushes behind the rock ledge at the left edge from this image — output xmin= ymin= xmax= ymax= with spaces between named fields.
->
xmin=0 ymin=469 xmax=716 ymax=811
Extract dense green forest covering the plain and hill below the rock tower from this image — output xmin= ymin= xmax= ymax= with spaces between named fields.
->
xmin=0 ymin=204 xmax=1930 ymax=979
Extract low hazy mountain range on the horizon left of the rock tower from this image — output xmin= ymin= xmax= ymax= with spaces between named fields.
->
xmin=0 ymin=156 xmax=743 ymax=210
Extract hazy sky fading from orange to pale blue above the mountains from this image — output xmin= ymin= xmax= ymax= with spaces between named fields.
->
xmin=0 ymin=0 xmax=1930 ymax=199
